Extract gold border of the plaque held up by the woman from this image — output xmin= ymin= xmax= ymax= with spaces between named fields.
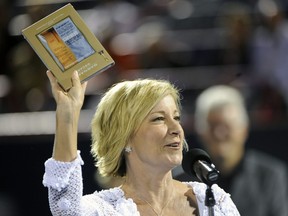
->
xmin=22 ymin=3 xmax=115 ymax=91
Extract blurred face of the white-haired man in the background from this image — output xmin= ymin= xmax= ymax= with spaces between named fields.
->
xmin=201 ymin=105 xmax=247 ymax=170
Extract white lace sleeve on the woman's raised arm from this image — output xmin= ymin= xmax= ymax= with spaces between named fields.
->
xmin=43 ymin=151 xmax=84 ymax=216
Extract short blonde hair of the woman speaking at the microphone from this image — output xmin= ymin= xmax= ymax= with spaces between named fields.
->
xmin=91 ymin=79 xmax=187 ymax=176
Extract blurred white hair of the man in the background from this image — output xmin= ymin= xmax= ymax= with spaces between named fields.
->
xmin=195 ymin=85 xmax=249 ymax=134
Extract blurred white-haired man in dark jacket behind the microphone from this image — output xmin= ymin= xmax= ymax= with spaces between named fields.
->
xmin=175 ymin=85 xmax=288 ymax=216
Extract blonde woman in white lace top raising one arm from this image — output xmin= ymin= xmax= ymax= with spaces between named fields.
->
xmin=43 ymin=71 xmax=239 ymax=216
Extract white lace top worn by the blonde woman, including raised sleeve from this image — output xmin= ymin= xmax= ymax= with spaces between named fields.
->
xmin=43 ymin=153 xmax=240 ymax=216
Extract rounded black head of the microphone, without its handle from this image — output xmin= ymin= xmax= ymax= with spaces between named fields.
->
xmin=182 ymin=148 xmax=212 ymax=177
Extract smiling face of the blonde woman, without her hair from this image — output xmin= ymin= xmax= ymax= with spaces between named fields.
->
xmin=129 ymin=95 xmax=184 ymax=170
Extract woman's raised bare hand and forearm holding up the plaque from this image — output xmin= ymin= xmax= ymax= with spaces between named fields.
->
xmin=47 ymin=71 xmax=87 ymax=162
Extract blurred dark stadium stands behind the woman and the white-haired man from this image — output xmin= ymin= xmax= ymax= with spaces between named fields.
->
xmin=0 ymin=0 xmax=288 ymax=216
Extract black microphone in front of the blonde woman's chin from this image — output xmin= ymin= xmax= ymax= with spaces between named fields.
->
xmin=182 ymin=148 xmax=219 ymax=186
